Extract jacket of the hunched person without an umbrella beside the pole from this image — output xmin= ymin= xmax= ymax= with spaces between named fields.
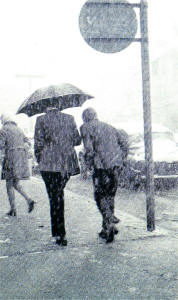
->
xmin=80 ymin=119 xmax=129 ymax=169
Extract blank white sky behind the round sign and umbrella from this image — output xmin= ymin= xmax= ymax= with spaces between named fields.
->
xmin=0 ymin=0 xmax=178 ymax=129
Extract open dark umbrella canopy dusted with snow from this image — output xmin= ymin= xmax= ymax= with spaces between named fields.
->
xmin=17 ymin=83 xmax=93 ymax=117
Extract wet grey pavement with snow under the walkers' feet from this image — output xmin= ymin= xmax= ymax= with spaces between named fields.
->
xmin=0 ymin=178 xmax=177 ymax=300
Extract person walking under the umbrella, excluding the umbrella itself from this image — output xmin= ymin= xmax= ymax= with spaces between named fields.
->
xmin=34 ymin=108 xmax=81 ymax=246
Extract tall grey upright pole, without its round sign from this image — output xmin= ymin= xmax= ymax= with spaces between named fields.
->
xmin=140 ymin=0 xmax=155 ymax=231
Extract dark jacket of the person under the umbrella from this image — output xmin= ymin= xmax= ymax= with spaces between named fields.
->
xmin=34 ymin=109 xmax=81 ymax=176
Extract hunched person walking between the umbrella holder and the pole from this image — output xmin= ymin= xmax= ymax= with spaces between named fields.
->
xmin=80 ymin=108 xmax=129 ymax=243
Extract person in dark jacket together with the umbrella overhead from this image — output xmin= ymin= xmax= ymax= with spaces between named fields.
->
xmin=17 ymin=83 xmax=93 ymax=246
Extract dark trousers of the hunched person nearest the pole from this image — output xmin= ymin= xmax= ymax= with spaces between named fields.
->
xmin=93 ymin=167 xmax=120 ymax=230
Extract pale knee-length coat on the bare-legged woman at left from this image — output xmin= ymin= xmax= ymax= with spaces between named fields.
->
xmin=0 ymin=122 xmax=30 ymax=179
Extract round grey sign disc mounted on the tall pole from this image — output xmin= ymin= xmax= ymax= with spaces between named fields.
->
xmin=79 ymin=0 xmax=137 ymax=53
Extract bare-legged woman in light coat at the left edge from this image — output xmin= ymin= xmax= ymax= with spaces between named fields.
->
xmin=0 ymin=114 xmax=35 ymax=216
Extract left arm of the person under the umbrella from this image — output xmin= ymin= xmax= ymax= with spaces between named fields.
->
xmin=34 ymin=118 xmax=44 ymax=163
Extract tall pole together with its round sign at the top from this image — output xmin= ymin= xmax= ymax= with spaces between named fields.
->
xmin=79 ymin=0 xmax=155 ymax=231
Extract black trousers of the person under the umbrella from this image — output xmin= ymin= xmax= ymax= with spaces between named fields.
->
xmin=40 ymin=171 xmax=69 ymax=237
